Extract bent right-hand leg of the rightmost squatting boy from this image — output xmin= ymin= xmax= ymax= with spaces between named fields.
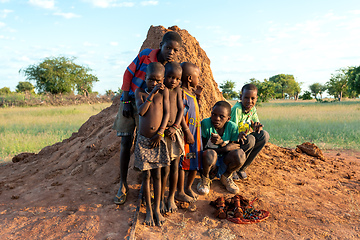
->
xmin=239 ymin=130 xmax=270 ymax=173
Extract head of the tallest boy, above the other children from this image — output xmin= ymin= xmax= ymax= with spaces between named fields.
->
xmin=160 ymin=31 xmax=182 ymax=62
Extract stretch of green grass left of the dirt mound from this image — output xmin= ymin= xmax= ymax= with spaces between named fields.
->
xmin=0 ymin=103 xmax=111 ymax=162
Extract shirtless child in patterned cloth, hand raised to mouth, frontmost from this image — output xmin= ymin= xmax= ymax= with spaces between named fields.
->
xmin=134 ymin=62 xmax=170 ymax=226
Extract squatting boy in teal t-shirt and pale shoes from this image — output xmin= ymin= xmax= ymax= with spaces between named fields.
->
xmin=197 ymin=101 xmax=245 ymax=194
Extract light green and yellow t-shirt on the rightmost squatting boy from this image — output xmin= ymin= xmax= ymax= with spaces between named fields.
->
xmin=231 ymin=102 xmax=259 ymax=132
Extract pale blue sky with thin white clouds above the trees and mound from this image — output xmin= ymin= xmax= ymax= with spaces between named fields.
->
xmin=0 ymin=0 xmax=360 ymax=94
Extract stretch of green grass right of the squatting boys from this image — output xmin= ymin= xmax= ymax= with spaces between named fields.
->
xmin=258 ymin=100 xmax=360 ymax=150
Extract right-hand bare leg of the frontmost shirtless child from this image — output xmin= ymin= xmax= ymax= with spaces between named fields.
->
xmin=149 ymin=168 xmax=165 ymax=226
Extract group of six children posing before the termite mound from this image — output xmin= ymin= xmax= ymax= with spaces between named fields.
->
xmin=114 ymin=31 xmax=269 ymax=226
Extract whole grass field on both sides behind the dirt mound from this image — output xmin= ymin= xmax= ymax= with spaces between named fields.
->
xmin=0 ymin=100 xmax=360 ymax=162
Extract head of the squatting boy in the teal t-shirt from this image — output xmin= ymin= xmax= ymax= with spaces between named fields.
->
xmin=210 ymin=101 xmax=231 ymax=129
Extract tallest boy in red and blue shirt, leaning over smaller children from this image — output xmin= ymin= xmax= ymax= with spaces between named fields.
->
xmin=113 ymin=31 xmax=182 ymax=204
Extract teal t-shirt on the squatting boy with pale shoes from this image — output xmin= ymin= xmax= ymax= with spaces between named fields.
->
xmin=201 ymin=118 xmax=239 ymax=149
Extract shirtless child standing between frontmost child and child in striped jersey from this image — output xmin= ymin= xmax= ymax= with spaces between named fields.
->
xmin=160 ymin=62 xmax=184 ymax=212
